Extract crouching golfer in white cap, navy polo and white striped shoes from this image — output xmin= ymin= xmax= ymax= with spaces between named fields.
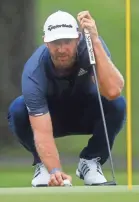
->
xmin=8 ymin=11 xmax=126 ymax=187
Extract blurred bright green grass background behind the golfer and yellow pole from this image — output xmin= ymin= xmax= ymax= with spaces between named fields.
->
xmin=35 ymin=0 xmax=139 ymax=157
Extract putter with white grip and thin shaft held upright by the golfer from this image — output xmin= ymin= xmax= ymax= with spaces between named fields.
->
xmin=84 ymin=29 xmax=116 ymax=186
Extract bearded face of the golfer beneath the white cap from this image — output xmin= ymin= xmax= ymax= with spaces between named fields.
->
xmin=47 ymin=39 xmax=79 ymax=73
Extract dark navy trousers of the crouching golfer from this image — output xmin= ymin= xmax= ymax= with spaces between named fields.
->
xmin=8 ymin=91 xmax=126 ymax=165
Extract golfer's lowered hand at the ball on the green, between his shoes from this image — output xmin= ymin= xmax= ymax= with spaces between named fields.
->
xmin=48 ymin=171 xmax=72 ymax=186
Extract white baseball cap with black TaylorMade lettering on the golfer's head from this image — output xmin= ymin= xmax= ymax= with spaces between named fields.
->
xmin=43 ymin=11 xmax=79 ymax=42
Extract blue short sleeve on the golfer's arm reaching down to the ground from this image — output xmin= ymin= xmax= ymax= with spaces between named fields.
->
xmin=22 ymin=75 xmax=48 ymax=116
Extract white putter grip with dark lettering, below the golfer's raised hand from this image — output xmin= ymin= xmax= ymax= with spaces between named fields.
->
xmin=84 ymin=29 xmax=96 ymax=65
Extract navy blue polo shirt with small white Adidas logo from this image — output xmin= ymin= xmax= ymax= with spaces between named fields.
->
xmin=22 ymin=35 xmax=110 ymax=116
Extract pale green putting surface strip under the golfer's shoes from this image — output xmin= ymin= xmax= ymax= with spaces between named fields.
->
xmin=0 ymin=186 xmax=139 ymax=202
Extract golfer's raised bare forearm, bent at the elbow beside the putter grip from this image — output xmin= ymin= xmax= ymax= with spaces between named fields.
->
xmin=93 ymin=39 xmax=124 ymax=99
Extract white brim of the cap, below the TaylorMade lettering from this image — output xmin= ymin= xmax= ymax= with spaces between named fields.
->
xmin=44 ymin=33 xmax=79 ymax=42
